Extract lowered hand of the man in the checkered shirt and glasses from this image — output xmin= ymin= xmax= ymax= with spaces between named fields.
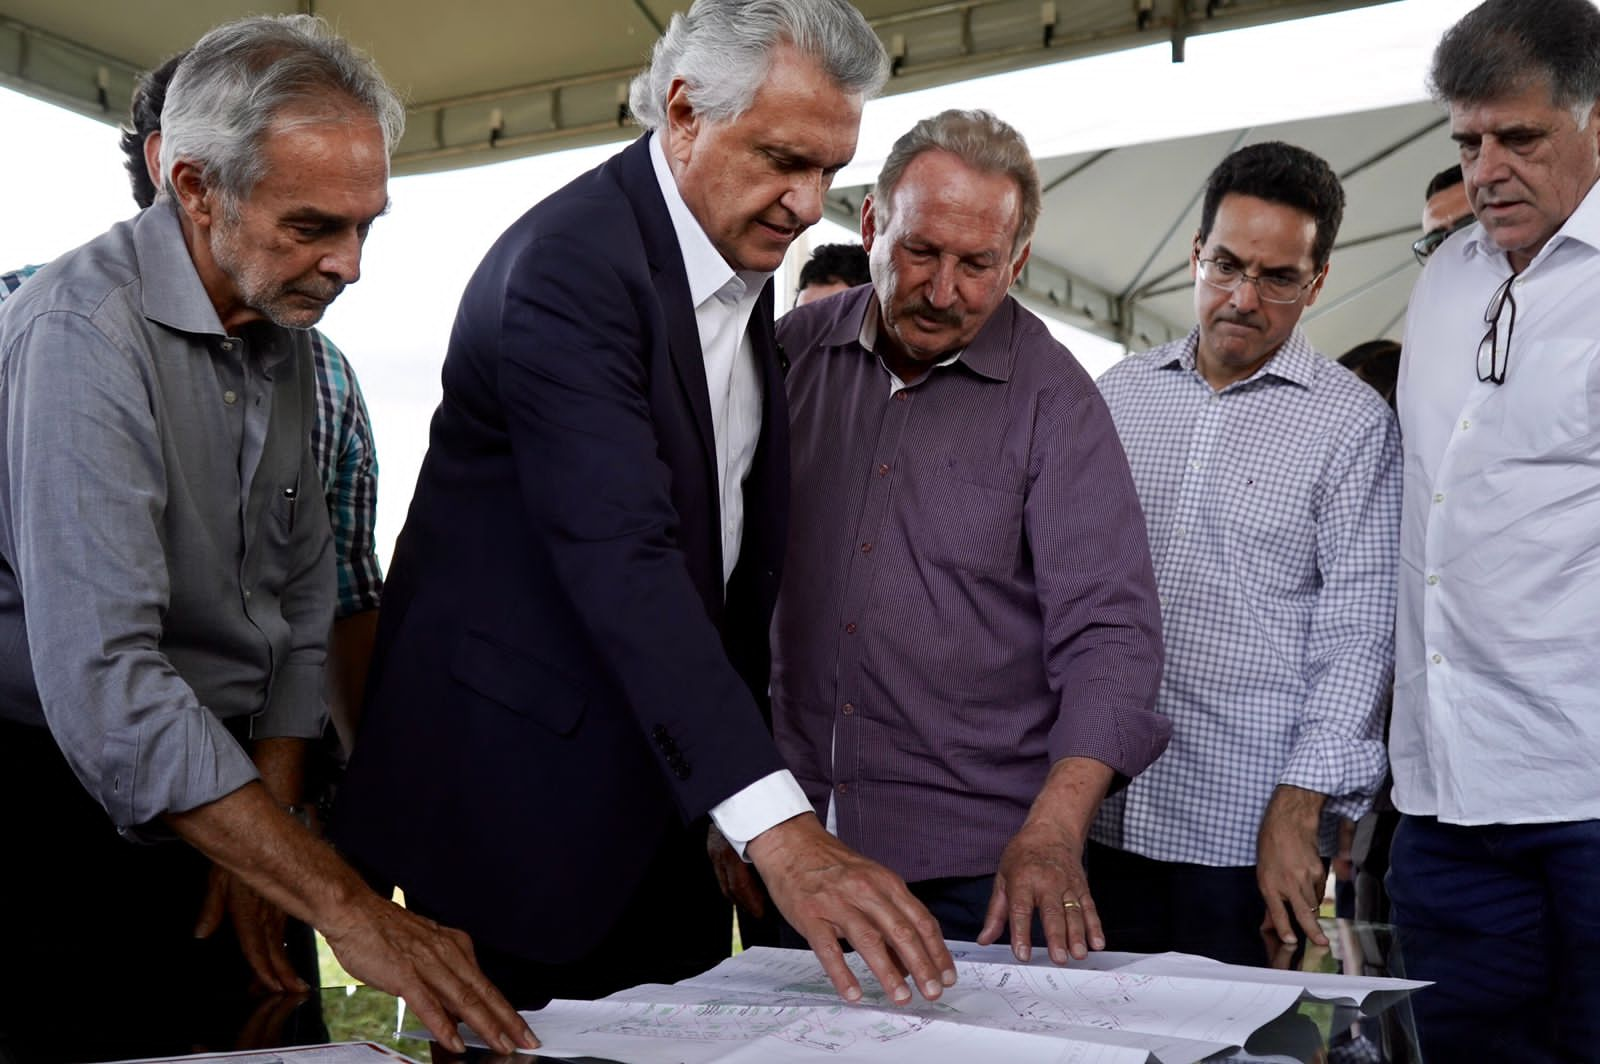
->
xmin=1256 ymin=784 xmax=1328 ymax=946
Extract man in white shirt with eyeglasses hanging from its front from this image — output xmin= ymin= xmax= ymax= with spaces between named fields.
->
xmin=1389 ymin=0 xmax=1600 ymax=1059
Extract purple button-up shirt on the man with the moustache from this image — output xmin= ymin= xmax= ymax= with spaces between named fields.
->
xmin=773 ymin=286 xmax=1170 ymax=882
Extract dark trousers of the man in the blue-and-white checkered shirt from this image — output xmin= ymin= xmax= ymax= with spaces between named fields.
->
xmin=1085 ymin=842 xmax=1270 ymax=965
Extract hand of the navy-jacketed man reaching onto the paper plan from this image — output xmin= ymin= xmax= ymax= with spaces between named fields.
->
xmin=746 ymin=813 xmax=955 ymax=1005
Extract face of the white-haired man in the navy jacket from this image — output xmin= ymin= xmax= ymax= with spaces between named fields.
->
xmin=662 ymin=45 xmax=861 ymax=274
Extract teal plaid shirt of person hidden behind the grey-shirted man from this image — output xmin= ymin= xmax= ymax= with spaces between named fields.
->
xmin=0 ymin=266 xmax=384 ymax=618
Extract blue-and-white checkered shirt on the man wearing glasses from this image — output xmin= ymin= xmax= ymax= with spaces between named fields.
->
xmin=1093 ymin=330 xmax=1400 ymax=867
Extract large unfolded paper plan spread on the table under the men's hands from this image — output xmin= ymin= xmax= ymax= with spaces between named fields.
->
xmin=448 ymin=942 xmax=1424 ymax=1064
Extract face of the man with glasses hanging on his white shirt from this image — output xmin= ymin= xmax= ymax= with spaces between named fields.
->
xmin=1450 ymin=80 xmax=1600 ymax=269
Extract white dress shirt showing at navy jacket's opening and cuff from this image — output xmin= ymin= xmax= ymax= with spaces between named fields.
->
xmin=650 ymin=136 xmax=811 ymax=856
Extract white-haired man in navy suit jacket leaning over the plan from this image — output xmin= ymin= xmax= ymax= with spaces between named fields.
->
xmin=336 ymin=0 xmax=955 ymax=1006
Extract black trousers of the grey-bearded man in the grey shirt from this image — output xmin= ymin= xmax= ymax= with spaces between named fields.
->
xmin=0 ymin=722 xmax=325 ymax=1062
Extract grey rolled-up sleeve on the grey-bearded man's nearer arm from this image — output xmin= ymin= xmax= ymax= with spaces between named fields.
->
xmin=0 ymin=312 xmax=256 ymax=829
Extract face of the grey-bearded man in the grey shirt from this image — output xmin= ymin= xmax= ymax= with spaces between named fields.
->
xmin=187 ymin=108 xmax=389 ymax=328
